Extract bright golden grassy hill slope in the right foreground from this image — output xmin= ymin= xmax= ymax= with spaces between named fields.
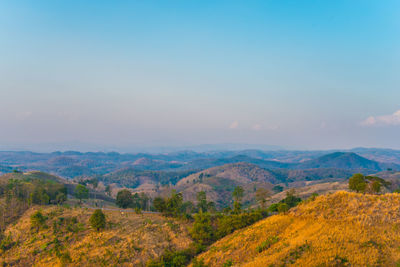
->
xmin=198 ymin=192 xmax=400 ymax=266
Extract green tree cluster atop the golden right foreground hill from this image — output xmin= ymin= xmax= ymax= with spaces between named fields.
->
xmin=349 ymin=173 xmax=391 ymax=194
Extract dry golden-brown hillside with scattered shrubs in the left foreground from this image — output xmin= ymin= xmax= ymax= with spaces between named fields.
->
xmin=0 ymin=206 xmax=192 ymax=266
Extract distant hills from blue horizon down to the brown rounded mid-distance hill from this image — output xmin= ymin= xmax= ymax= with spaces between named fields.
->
xmin=0 ymin=149 xmax=400 ymax=207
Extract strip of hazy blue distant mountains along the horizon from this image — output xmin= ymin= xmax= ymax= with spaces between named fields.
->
xmin=0 ymin=151 xmax=400 ymax=178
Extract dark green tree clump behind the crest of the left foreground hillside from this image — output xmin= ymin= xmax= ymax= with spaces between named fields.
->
xmin=116 ymin=189 xmax=150 ymax=210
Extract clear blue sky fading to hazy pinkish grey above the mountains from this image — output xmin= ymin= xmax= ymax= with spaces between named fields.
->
xmin=0 ymin=0 xmax=400 ymax=151
